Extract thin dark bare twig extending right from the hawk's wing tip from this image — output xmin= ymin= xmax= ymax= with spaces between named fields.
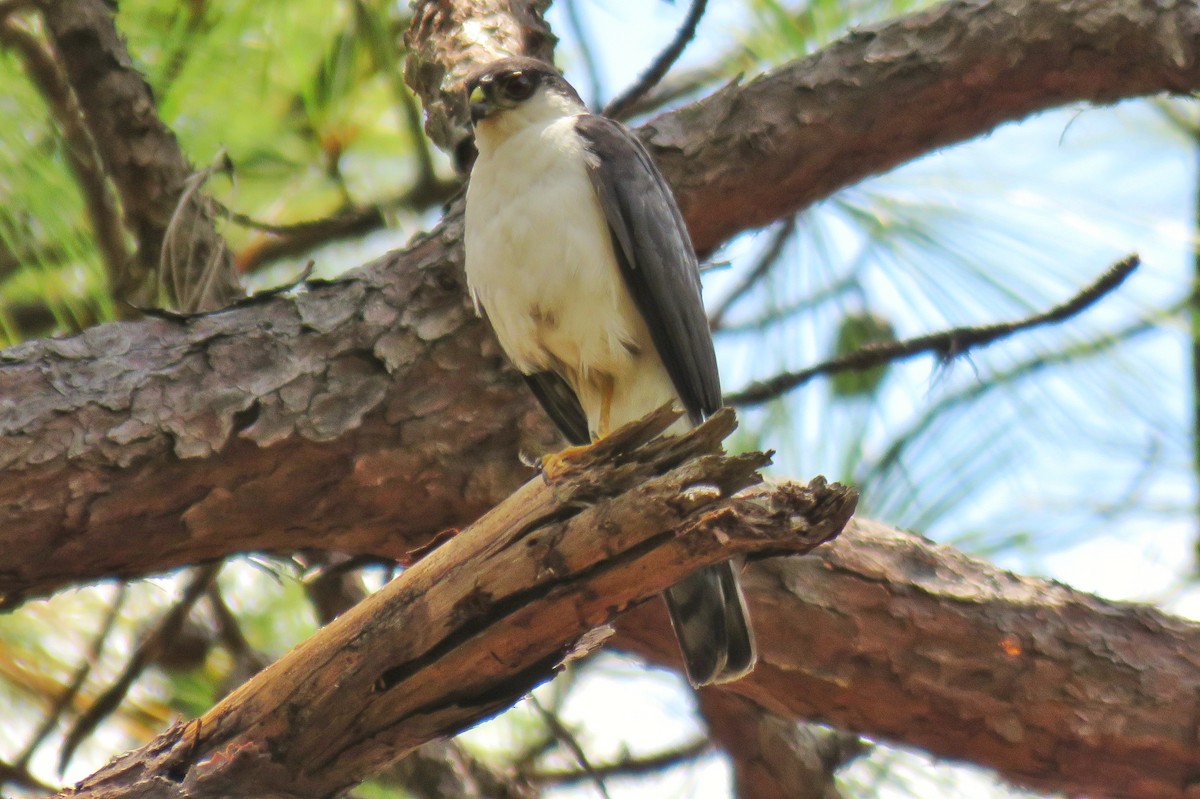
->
xmin=725 ymin=256 xmax=1141 ymax=405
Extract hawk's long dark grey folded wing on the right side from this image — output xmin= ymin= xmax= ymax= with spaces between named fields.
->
xmin=575 ymin=114 xmax=721 ymax=423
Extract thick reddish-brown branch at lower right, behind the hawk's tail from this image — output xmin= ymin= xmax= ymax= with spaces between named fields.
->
xmin=614 ymin=519 xmax=1200 ymax=799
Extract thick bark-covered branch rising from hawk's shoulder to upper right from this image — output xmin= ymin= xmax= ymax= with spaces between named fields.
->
xmin=638 ymin=0 xmax=1200 ymax=252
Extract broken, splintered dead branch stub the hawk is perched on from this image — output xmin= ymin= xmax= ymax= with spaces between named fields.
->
xmin=65 ymin=409 xmax=856 ymax=797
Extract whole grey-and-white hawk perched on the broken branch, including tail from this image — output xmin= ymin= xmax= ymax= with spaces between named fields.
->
xmin=466 ymin=58 xmax=756 ymax=686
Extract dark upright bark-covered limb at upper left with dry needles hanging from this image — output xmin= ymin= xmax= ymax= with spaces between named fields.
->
xmin=38 ymin=0 xmax=242 ymax=311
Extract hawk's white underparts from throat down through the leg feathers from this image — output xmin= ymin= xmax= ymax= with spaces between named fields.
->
xmin=466 ymin=89 xmax=676 ymax=433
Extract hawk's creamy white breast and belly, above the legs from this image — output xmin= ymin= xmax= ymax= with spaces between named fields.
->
xmin=466 ymin=116 xmax=648 ymax=379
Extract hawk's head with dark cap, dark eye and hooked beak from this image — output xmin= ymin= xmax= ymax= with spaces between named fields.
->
xmin=467 ymin=58 xmax=586 ymax=141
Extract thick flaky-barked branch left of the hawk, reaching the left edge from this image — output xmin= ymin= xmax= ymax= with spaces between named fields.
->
xmin=0 ymin=216 xmax=552 ymax=603
